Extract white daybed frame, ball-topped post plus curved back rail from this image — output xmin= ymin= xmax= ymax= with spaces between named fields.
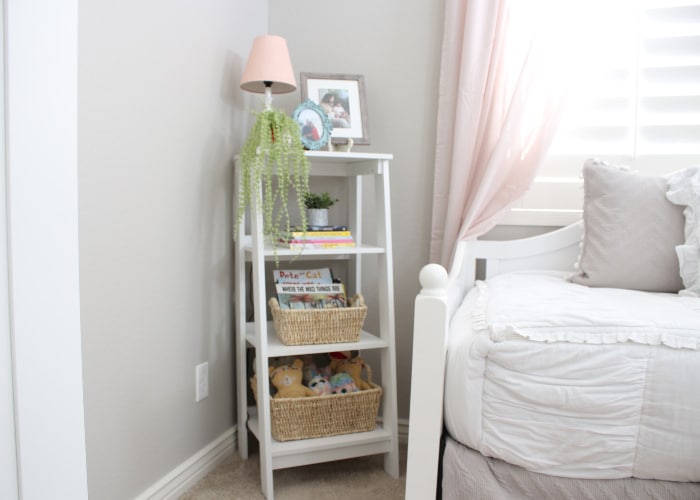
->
xmin=406 ymin=222 xmax=583 ymax=500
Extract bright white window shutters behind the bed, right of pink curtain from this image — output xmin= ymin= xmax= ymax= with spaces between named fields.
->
xmin=501 ymin=0 xmax=700 ymax=225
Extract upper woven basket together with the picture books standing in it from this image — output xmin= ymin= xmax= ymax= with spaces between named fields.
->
xmin=269 ymin=268 xmax=367 ymax=345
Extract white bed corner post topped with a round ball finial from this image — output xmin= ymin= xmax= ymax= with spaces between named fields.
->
xmin=406 ymin=264 xmax=448 ymax=500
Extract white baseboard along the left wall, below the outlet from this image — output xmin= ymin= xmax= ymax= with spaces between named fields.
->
xmin=135 ymin=427 xmax=236 ymax=500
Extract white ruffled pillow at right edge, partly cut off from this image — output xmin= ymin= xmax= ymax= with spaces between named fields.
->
xmin=666 ymin=167 xmax=700 ymax=297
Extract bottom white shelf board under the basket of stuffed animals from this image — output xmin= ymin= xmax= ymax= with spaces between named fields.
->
xmin=248 ymin=407 xmax=392 ymax=470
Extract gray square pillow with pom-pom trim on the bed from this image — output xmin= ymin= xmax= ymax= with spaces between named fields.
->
xmin=571 ymin=159 xmax=685 ymax=293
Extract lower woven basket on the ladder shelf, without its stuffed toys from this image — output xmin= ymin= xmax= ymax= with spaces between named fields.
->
xmin=250 ymin=366 xmax=382 ymax=441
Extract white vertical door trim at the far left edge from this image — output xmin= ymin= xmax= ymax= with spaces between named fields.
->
xmin=0 ymin=0 xmax=88 ymax=500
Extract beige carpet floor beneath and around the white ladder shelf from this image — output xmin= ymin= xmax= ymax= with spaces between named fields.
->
xmin=180 ymin=445 xmax=406 ymax=500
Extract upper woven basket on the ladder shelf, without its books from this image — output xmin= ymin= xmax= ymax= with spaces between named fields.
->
xmin=269 ymin=294 xmax=367 ymax=345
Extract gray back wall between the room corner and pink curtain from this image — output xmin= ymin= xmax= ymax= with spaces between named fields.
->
xmin=269 ymin=0 xmax=444 ymax=418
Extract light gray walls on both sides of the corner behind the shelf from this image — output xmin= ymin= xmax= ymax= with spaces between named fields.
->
xmin=78 ymin=0 xmax=443 ymax=500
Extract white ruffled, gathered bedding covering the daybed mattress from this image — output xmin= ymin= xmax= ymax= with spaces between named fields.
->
xmin=445 ymin=272 xmax=700 ymax=481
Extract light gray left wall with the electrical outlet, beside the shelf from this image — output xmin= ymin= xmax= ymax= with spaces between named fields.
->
xmin=78 ymin=0 xmax=267 ymax=500
